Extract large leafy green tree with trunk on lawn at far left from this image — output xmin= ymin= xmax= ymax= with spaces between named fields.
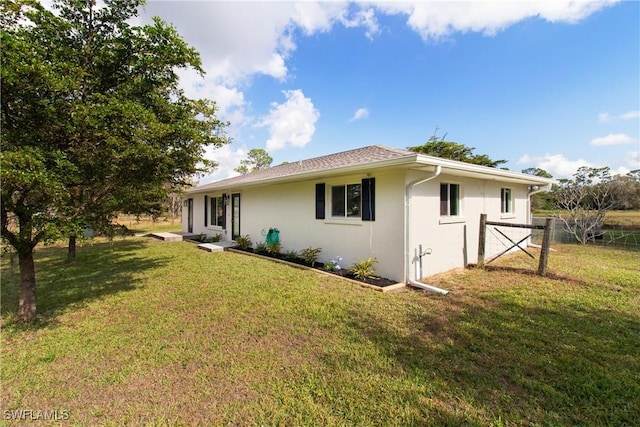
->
xmin=1 ymin=0 xmax=228 ymax=322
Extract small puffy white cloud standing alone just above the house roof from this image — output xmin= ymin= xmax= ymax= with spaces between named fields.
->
xmin=258 ymin=89 xmax=320 ymax=151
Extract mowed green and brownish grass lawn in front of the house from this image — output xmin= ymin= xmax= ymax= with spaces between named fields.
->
xmin=0 ymin=239 xmax=640 ymax=426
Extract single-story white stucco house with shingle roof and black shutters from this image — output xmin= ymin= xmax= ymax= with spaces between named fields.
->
xmin=182 ymin=146 xmax=552 ymax=283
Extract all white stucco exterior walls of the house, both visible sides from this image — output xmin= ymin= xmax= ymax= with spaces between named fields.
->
xmin=183 ymin=169 xmax=529 ymax=281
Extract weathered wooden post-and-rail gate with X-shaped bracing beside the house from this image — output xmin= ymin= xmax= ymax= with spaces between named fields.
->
xmin=478 ymin=214 xmax=553 ymax=276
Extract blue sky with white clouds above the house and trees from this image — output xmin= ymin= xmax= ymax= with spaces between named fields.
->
xmin=142 ymin=0 xmax=640 ymax=182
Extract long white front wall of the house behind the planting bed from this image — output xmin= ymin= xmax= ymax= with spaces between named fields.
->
xmin=183 ymin=171 xmax=404 ymax=281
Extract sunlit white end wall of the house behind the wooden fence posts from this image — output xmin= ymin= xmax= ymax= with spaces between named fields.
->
xmin=407 ymin=172 xmax=529 ymax=279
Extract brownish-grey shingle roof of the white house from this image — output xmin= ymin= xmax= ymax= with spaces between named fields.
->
xmin=190 ymin=145 xmax=416 ymax=192
